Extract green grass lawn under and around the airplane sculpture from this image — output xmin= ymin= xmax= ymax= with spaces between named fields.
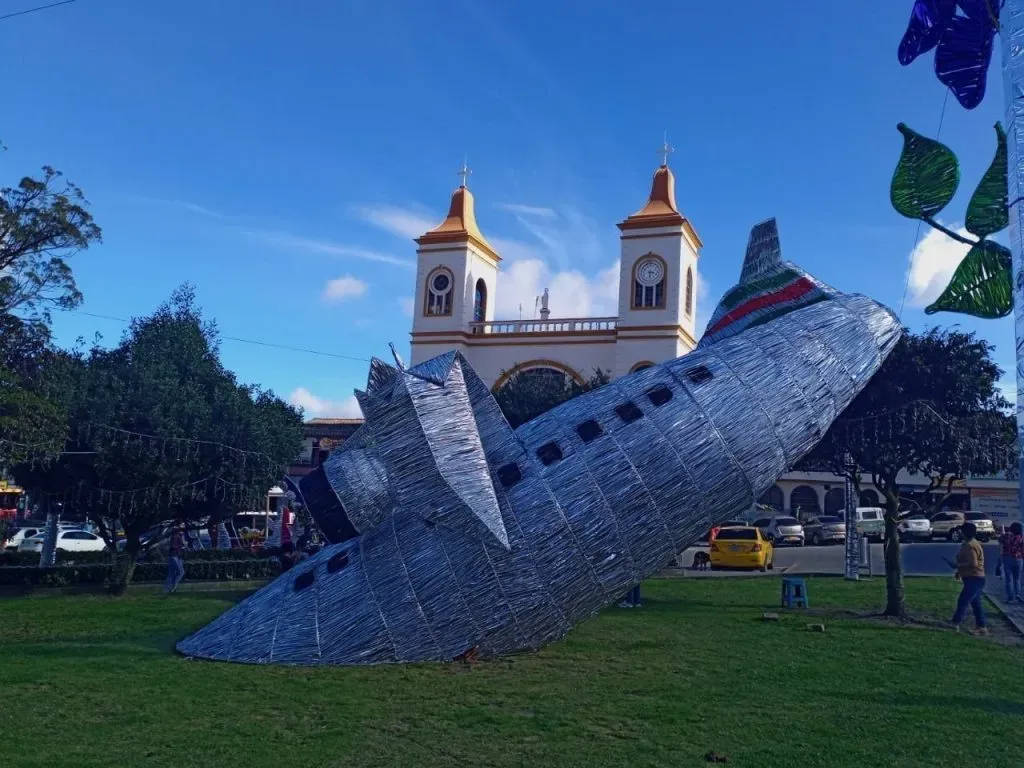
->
xmin=0 ymin=579 xmax=1024 ymax=768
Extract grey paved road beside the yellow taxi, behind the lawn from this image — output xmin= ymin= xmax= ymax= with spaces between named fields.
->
xmin=683 ymin=542 xmax=999 ymax=578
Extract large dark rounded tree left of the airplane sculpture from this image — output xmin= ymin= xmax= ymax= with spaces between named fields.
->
xmin=15 ymin=286 xmax=302 ymax=592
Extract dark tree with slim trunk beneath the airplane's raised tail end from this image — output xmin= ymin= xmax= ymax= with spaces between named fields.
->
xmin=801 ymin=329 xmax=1015 ymax=616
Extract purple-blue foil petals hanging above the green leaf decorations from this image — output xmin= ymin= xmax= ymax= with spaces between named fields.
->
xmin=899 ymin=0 xmax=1001 ymax=110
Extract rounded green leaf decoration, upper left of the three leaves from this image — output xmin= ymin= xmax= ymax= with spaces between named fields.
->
xmin=889 ymin=123 xmax=959 ymax=219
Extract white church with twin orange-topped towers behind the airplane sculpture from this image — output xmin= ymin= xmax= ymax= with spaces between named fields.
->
xmin=411 ymin=154 xmax=702 ymax=391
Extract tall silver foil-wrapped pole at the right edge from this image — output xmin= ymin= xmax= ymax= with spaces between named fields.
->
xmin=999 ymin=0 xmax=1024 ymax=520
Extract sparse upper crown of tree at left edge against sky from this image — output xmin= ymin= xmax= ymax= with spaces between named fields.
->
xmin=0 ymin=159 xmax=101 ymax=317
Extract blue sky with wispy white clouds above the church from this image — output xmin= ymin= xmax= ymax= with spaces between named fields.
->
xmin=0 ymin=0 xmax=1014 ymax=415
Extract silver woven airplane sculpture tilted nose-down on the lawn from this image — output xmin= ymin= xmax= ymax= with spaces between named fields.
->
xmin=177 ymin=219 xmax=901 ymax=665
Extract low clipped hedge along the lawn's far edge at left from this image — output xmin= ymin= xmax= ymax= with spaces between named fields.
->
xmin=0 ymin=552 xmax=281 ymax=587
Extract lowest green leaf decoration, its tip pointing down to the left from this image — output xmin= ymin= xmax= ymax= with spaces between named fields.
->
xmin=925 ymin=240 xmax=1014 ymax=319
